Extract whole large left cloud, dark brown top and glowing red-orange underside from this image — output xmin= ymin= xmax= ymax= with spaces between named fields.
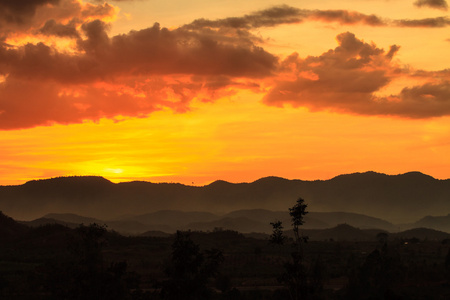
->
xmin=0 ymin=12 xmax=278 ymax=129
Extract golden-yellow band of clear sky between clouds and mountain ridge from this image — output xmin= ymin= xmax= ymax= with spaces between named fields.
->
xmin=0 ymin=92 xmax=450 ymax=185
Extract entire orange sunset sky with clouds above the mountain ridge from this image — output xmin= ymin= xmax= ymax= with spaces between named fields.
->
xmin=0 ymin=0 xmax=450 ymax=185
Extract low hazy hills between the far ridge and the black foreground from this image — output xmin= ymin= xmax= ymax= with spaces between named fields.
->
xmin=14 ymin=209 xmax=450 ymax=240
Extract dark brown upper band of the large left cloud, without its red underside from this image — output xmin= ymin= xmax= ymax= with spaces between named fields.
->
xmin=0 ymin=20 xmax=277 ymax=83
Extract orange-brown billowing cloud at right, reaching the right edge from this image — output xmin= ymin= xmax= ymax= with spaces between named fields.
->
xmin=263 ymin=32 xmax=450 ymax=118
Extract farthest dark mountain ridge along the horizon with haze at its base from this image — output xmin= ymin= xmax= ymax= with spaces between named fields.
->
xmin=0 ymin=172 xmax=450 ymax=223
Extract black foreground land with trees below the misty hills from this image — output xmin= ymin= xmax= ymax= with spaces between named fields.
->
xmin=0 ymin=207 xmax=450 ymax=300
